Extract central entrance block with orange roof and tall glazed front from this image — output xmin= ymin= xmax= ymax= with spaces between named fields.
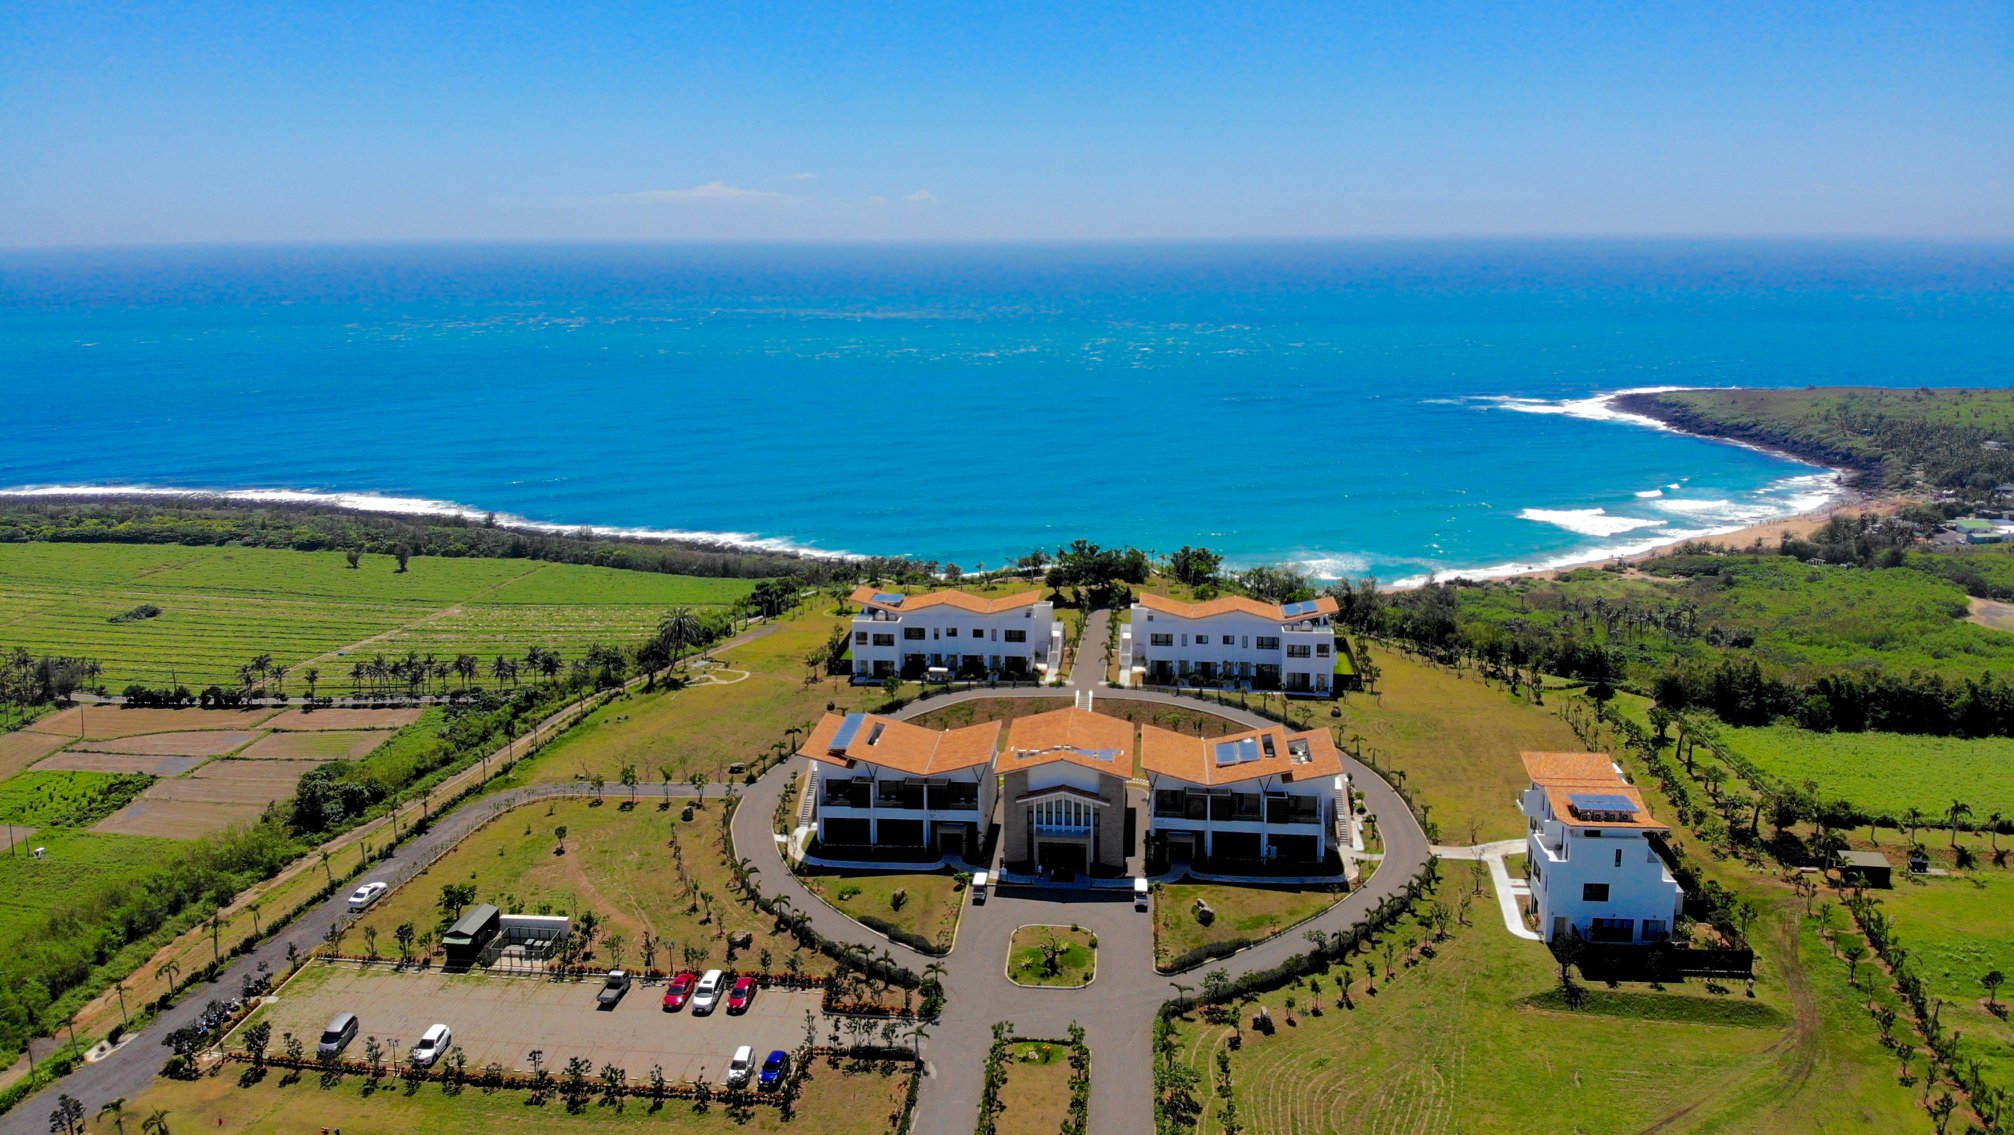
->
xmin=993 ymin=708 xmax=1134 ymax=879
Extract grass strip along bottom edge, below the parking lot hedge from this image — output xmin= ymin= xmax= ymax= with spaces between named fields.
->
xmin=119 ymin=1061 xmax=908 ymax=1135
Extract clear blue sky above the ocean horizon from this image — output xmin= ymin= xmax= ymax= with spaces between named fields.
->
xmin=0 ymin=0 xmax=2014 ymax=246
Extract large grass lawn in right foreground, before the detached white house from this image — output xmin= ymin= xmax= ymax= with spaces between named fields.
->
xmin=1172 ymin=881 xmax=1931 ymax=1135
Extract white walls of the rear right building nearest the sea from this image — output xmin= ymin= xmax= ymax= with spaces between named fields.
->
xmin=1122 ymin=604 xmax=1335 ymax=692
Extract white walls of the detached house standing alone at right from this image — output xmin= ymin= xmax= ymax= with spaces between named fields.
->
xmin=1519 ymin=787 xmax=1684 ymax=942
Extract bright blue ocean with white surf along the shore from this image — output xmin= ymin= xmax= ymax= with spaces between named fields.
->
xmin=0 ymin=241 xmax=2014 ymax=582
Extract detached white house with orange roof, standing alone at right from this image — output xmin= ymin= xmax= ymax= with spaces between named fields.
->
xmin=1519 ymin=753 xmax=1684 ymax=944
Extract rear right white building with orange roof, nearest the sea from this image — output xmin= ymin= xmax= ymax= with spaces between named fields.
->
xmin=1120 ymin=594 xmax=1339 ymax=698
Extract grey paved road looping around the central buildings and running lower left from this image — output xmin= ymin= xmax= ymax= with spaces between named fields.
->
xmin=0 ymin=612 xmax=1432 ymax=1135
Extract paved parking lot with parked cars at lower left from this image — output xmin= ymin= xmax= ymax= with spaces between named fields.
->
xmin=243 ymin=964 xmax=828 ymax=1083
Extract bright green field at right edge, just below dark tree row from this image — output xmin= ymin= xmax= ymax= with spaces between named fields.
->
xmin=1722 ymin=724 xmax=2014 ymax=819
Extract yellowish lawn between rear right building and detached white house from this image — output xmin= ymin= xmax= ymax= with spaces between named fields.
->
xmin=1341 ymin=650 xmax=1583 ymax=843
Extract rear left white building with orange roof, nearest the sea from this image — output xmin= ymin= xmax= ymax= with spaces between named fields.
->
xmin=852 ymin=588 xmax=1063 ymax=682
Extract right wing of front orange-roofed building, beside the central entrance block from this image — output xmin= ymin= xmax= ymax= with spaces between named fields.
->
xmin=1140 ymin=724 xmax=1349 ymax=869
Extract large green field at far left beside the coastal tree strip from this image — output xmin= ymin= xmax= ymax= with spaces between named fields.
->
xmin=0 ymin=543 xmax=753 ymax=694
